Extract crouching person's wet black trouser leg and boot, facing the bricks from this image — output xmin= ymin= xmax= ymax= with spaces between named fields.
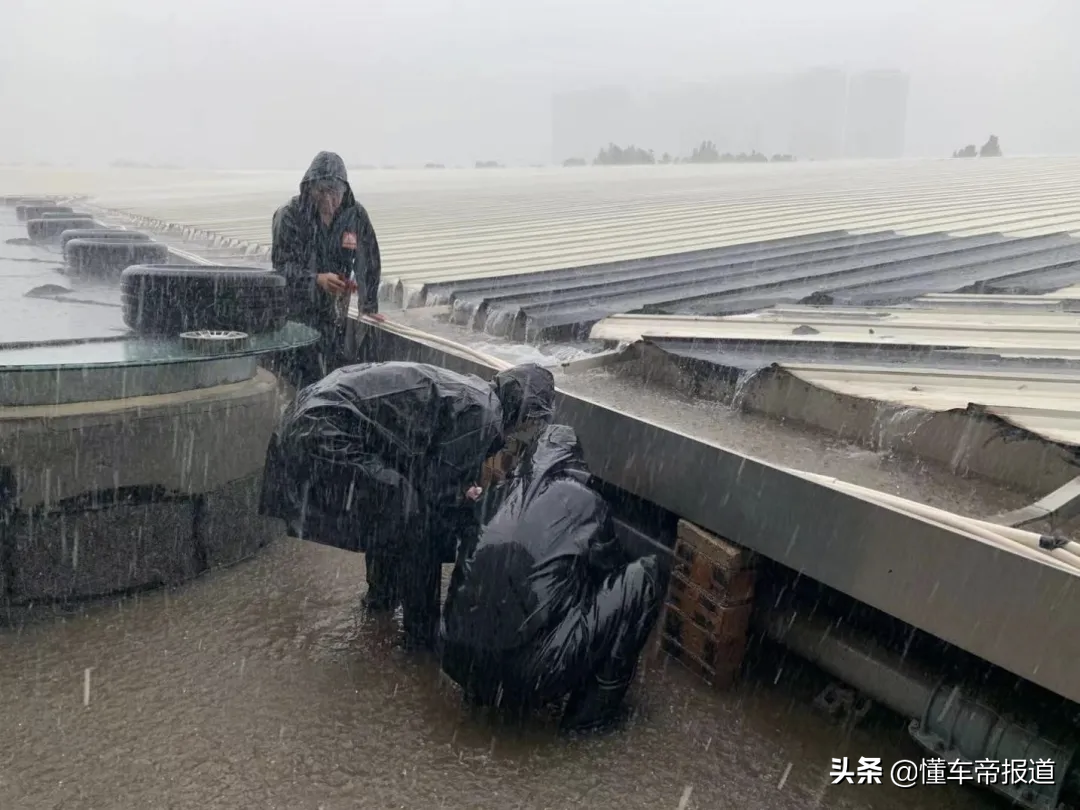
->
xmin=562 ymin=556 xmax=662 ymax=731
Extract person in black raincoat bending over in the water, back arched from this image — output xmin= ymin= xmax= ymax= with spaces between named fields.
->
xmin=260 ymin=363 xmax=555 ymax=647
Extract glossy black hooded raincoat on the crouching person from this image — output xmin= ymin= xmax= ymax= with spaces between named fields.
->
xmin=442 ymin=424 xmax=625 ymax=656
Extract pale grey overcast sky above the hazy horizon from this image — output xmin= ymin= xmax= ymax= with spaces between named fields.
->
xmin=0 ymin=0 xmax=1080 ymax=168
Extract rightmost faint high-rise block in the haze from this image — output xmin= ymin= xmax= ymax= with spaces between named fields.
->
xmin=843 ymin=70 xmax=909 ymax=158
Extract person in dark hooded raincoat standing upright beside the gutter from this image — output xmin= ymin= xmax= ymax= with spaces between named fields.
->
xmin=270 ymin=152 xmax=382 ymax=388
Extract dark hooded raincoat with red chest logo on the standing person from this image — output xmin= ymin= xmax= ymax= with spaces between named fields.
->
xmin=270 ymin=152 xmax=382 ymax=328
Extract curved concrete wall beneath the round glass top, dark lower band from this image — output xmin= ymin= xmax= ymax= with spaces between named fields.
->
xmin=0 ymin=370 xmax=281 ymax=621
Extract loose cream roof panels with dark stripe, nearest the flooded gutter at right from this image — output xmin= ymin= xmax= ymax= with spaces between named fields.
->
xmin=592 ymin=301 xmax=1080 ymax=445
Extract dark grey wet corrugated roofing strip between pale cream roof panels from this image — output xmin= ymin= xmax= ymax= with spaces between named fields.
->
xmin=428 ymin=231 xmax=1080 ymax=336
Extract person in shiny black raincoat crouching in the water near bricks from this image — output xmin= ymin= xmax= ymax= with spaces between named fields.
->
xmin=440 ymin=424 xmax=662 ymax=730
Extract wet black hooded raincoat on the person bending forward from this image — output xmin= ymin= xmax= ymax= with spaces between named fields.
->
xmin=255 ymin=363 xmax=554 ymax=544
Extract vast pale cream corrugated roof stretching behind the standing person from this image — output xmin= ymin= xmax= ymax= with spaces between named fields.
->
xmin=6 ymin=158 xmax=1080 ymax=294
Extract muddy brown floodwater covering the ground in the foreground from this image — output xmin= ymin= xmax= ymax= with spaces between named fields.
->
xmin=0 ymin=539 xmax=997 ymax=810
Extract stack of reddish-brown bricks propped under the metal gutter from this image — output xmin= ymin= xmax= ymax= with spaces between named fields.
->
xmin=659 ymin=521 xmax=754 ymax=688
